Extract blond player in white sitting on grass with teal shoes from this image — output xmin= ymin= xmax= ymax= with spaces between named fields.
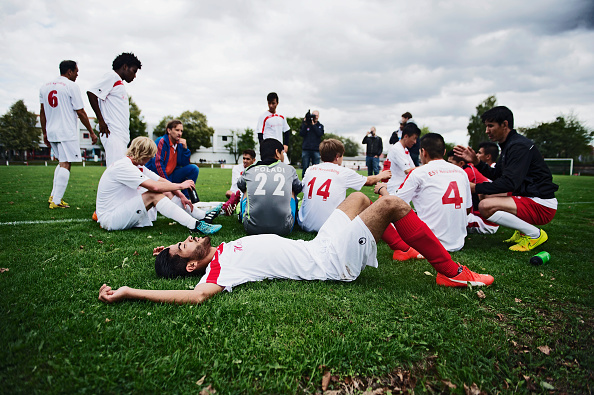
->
xmin=96 ymin=137 xmax=221 ymax=234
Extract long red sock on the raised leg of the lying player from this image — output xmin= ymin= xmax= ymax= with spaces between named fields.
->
xmin=394 ymin=210 xmax=460 ymax=277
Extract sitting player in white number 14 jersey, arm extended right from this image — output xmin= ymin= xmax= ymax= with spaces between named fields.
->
xmin=298 ymin=139 xmax=391 ymax=232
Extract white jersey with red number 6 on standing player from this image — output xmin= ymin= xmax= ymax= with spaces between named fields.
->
xmin=39 ymin=76 xmax=84 ymax=143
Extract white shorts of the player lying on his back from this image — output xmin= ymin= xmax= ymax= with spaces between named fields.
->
xmin=310 ymin=209 xmax=377 ymax=281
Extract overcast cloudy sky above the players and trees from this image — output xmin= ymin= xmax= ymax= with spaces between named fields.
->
xmin=0 ymin=0 xmax=594 ymax=144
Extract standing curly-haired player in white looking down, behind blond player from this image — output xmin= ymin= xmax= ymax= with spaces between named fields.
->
xmin=87 ymin=53 xmax=142 ymax=167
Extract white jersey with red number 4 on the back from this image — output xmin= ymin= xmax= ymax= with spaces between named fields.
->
xmin=396 ymin=159 xmax=472 ymax=251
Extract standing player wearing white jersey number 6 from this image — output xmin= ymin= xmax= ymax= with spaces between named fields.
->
xmin=39 ymin=60 xmax=97 ymax=209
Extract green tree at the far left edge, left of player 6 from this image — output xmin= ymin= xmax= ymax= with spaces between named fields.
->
xmin=0 ymin=100 xmax=41 ymax=160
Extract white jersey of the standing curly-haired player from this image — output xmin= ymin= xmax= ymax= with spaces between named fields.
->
xmin=89 ymin=70 xmax=130 ymax=145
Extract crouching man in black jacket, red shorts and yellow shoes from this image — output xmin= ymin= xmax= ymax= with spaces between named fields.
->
xmin=454 ymin=106 xmax=559 ymax=251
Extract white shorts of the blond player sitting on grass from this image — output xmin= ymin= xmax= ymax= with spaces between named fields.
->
xmin=98 ymin=194 xmax=156 ymax=230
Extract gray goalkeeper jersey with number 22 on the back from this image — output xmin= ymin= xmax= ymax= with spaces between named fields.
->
xmin=237 ymin=161 xmax=302 ymax=236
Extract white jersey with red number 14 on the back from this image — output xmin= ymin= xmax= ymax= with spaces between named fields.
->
xmin=298 ymin=162 xmax=367 ymax=232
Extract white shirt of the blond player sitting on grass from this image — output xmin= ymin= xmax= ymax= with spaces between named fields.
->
xmin=95 ymin=156 xmax=159 ymax=216
